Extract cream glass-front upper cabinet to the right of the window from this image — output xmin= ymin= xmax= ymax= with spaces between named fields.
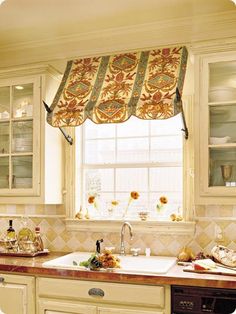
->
xmin=195 ymin=53 xmax=236 ymax=204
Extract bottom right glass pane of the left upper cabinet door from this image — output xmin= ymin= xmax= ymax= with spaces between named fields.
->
xmin=12 ymin=156 xmax=33 ymax=189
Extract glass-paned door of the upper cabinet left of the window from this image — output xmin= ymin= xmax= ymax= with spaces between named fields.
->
xmin=0 ymin=80 xmax=39 ymax=195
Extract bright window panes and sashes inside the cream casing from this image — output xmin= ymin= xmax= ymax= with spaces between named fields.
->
xmin=76 ymin=114 xmax=184 ymax=220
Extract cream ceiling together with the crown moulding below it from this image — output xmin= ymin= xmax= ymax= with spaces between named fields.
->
xmin=0 ymin=0 xmax=236 ymax=69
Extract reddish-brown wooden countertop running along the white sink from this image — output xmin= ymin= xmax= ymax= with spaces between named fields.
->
xmin=0 ymin=252 xmax=236 ymax=289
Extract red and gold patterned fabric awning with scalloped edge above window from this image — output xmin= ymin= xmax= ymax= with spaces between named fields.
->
xmin=47 ymin=47 xmax=188 ymax=127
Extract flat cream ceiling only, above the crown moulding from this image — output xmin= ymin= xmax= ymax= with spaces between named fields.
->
xmin=0 ymin=0 xmax=236 ymax=48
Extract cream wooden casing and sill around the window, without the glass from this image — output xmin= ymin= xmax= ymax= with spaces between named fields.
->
xmin=64 ymin=96 xmax=195 ymax=235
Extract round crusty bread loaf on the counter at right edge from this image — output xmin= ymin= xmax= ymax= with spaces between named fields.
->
xmin=211 ymin=245 xmax=236 ymax=267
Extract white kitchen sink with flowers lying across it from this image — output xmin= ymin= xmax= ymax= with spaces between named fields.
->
xmin=43 ymin=252 xmax=176 ymax=274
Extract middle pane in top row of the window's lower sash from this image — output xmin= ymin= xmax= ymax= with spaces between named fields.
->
xmin=116 ymin=168 xmax=148 ymax=192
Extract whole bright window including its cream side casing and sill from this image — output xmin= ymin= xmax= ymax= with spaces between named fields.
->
xmin=64 ymin=96 xmax=195 ymax=236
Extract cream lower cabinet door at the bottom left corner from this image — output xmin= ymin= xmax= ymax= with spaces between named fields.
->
xmin=0 ymin=274 xmax=35 ymax=314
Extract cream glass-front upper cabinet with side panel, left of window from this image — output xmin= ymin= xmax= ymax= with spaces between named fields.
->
xmin=0 ymin=67 xmax=62 ymax=204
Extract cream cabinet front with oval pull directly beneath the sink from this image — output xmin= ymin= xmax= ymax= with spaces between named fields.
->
xmin=36 ymin=277 xmax=170 ymax=314
